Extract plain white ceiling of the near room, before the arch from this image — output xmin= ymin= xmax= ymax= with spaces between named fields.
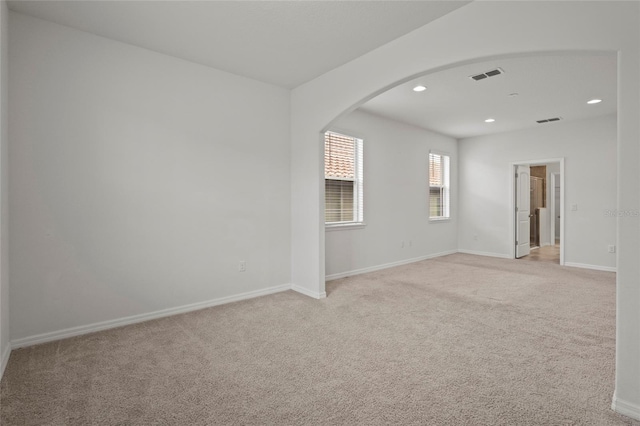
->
xmin=8 ymin=0 xmax=470 ymax=88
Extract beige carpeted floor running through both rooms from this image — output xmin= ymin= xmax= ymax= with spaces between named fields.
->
xmin=0 ymin=254 xmax=640 ymax=426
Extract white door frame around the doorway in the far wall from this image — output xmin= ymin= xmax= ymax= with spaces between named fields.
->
xmin=508 ymin=157 xmax=566 ymax=265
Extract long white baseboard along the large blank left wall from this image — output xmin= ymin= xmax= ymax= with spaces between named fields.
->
xmin=7 ymin=284 xmax=291 ymax=350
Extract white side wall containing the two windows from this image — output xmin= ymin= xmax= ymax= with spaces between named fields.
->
xmin=326 ymin=110 xmax=458 ymax=278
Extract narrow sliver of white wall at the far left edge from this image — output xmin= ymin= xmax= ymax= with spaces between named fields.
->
xmin=0 ymin=0 xmax=11 ymax=378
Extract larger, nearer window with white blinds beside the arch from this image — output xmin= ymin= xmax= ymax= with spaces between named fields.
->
xmin=324 ymin=132 xmax=363 ymax=225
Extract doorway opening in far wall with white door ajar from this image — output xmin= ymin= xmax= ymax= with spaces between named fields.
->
xmin=512 ymin=159 xmax=564 ymax=265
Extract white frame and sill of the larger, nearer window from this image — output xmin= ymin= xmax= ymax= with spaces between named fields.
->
xmin=321 ymin=129 xmax=366 ymax=231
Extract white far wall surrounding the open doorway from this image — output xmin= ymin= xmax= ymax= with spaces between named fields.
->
xmin=458 ymin=116 xmax=617 ymax=268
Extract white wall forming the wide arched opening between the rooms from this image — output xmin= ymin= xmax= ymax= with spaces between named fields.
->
xmin=291 ymin=1 xmax=640 ymax=419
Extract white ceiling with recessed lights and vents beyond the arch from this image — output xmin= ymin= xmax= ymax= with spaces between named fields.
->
xmin=361 ymin=54 xmax=617 ymax=139
